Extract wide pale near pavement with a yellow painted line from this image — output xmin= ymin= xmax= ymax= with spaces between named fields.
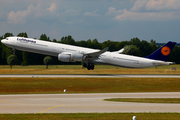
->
xmin=0 ymin=92 xmax=180 ymax=114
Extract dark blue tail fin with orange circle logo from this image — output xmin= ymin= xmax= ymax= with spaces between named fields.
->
xmin=145 ymin=41 xmax=176 ymax=61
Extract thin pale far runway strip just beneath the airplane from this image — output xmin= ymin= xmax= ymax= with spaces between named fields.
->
xmin=0 ymin=74 xmax=180 ymax=78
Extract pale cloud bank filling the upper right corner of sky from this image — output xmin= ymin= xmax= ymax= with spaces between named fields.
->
xmin=107 ymin=0 xmax=180 ymax=21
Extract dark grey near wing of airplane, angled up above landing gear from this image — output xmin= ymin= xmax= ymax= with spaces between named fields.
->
xmin=85 ymin=47 xmax=109 ymax=60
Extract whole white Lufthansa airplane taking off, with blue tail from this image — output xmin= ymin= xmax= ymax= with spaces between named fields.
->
xmin=1 ymin=36 xmax=176 ymax=70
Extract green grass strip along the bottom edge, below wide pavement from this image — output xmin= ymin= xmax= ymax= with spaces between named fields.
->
xmin=0 ymin=113 xmax=180 ymax=120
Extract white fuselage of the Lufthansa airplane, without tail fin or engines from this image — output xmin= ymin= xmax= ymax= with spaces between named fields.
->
xmin=1 ymin=37 xmax=171 ymax=68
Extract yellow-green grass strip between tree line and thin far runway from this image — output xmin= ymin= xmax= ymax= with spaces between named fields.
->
xmin=0 ymin=65 xmax=180 ymax=74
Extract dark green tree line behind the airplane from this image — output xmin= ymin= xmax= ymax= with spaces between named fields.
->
xmin=0 ymin=33 xmax=180 ymax=65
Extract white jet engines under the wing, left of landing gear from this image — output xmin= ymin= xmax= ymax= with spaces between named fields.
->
xmin=58 ymin=52 xmax=85 ymax=62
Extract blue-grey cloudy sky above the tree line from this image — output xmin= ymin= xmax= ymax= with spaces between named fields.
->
xmin=0 ymin=0 xmax=180 ymax=43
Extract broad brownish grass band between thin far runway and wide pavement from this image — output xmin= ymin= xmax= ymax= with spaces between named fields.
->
xmin=0 ymin=78 xmax=180 ymax=94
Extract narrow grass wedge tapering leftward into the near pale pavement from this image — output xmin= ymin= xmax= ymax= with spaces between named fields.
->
xmin=104 ymin=98 xmax=180 ymax=103
